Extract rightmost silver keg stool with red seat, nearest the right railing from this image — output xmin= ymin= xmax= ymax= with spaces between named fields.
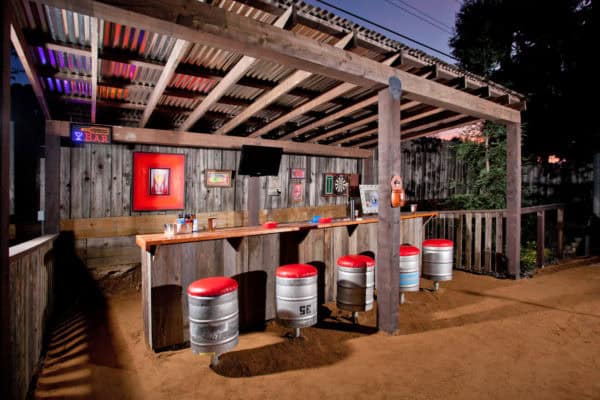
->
xmin=421 ymin=239 xmax=454 ymax=290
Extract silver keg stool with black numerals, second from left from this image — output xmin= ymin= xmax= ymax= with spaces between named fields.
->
xmin=275 ymin=264 xmax=317 ymax=337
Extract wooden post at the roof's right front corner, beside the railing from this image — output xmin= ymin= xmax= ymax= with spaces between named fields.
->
xmin=506 ymin=123 xmax=521 ymax=279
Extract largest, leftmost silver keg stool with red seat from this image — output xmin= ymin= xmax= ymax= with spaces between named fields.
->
xmin=188 ymin=276 xmax=238 ymax=366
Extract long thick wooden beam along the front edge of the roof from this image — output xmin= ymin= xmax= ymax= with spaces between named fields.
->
xmin=35 ymin=0 xmax=521 ymax=124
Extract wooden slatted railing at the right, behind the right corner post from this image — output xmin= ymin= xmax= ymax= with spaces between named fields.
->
xmin=424 ymin=204 xmax=564 ymax=275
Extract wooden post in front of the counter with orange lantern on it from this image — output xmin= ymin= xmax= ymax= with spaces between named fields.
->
xmin=376 ymin=80 xmax=401 ymax=333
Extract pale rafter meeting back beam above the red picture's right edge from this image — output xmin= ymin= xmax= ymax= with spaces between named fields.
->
xmin=178 ymin=7 xmax=292 ymax=131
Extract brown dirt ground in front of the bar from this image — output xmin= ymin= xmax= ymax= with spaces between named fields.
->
xmin=34 ymin=259 xmax=600 ymax=400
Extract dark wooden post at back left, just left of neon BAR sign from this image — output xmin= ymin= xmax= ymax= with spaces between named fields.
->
xmin=44 ymin=133 xmax=60 ymax=233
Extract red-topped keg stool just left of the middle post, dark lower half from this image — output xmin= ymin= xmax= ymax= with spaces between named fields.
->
xmin=336 ymin=255 xmax=375 ymax=323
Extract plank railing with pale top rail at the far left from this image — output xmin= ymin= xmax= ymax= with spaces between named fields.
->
xmin=3 ymin=235 xmax=56 ymax=399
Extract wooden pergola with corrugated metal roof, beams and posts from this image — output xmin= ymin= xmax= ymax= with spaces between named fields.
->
xmin=0 ymin=0 xmax=524 ymax=390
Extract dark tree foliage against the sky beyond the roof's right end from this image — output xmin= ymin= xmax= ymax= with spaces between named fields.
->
xmin=450 ymin=0 xmax=600 ymax=157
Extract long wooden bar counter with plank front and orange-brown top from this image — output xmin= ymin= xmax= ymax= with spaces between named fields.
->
xmin=136 ymin=213 xmax=436 ymax=351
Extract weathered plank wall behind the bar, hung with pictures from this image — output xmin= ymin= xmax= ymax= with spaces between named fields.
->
xmin=60 ymin=144 xmax=359 ymax=278
